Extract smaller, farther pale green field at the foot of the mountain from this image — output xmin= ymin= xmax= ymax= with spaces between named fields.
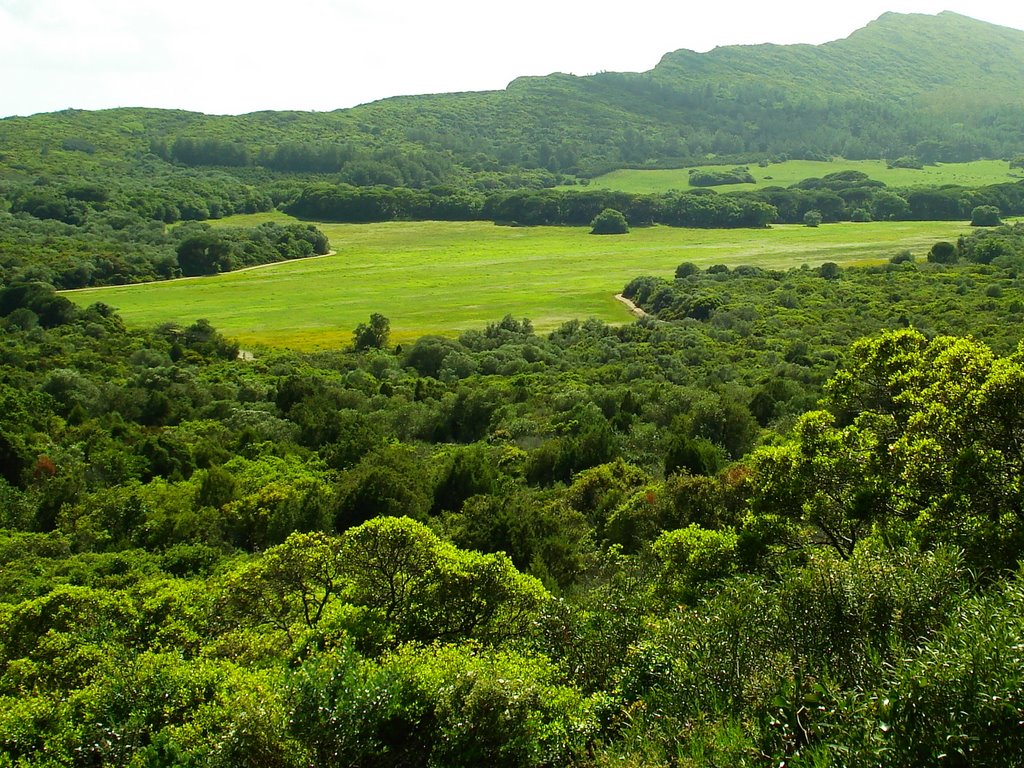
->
xmin=570 ymin=159 xmax=1024 ymax=193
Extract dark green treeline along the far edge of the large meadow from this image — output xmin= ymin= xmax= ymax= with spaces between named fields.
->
xmin=285 ymin=171 xmax=1024 ymax=228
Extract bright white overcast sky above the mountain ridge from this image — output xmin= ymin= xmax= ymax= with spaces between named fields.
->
xmin=0 ymin=0 xmax=1024 ymax=117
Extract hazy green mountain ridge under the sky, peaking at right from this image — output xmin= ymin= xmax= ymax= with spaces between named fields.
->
xmin=0 ymin=12 xmax=1024 ymax=188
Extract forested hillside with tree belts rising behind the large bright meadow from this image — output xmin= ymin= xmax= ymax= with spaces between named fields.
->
xmin=0 ymin=13 xmax=1024 ymax=288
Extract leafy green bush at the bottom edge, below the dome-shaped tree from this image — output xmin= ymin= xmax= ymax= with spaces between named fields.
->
xmin=289 ymin=646 xmax=598 ymax=768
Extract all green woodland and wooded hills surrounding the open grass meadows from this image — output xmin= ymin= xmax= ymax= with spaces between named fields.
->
xmin=0 ymin=7 xmax=1024 ymax=768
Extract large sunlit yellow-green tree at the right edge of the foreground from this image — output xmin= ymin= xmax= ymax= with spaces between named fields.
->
xmin=790 ymin=331 xmax=1024 ymax=570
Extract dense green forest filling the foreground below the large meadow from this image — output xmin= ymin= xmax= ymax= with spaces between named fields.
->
xmin=6 ymin=222 xmax=1024 ymax=766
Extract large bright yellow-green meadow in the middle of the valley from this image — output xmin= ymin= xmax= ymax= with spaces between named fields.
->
xmin=67 ymin=213 xmax=968 ymax=349
